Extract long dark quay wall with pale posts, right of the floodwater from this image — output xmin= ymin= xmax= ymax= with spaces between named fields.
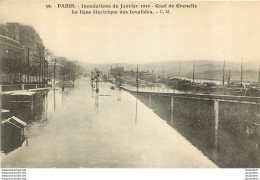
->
xmin=122 ymin=88 xmax=260 ymax=136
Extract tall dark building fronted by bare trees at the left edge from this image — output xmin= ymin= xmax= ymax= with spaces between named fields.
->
xmin=0 ymin=23 xmax=47 ymax=84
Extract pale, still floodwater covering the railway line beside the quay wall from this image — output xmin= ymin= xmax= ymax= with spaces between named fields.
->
xmin=1 ymin=78 xmax=217 ymax=168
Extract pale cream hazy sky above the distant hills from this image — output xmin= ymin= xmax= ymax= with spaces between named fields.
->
xmin=0 ymin=0 xmax=260 ymax=63
